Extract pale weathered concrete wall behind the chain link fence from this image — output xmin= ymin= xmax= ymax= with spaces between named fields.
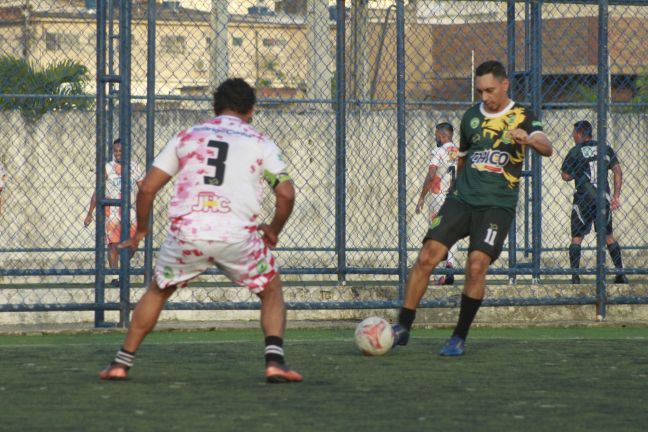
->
xmin=0 ymin=107 xmax=648 ymax=268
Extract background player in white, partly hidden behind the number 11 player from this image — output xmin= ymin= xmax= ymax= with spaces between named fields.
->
xmin=416 ymin=122 xmax=459 ymax=285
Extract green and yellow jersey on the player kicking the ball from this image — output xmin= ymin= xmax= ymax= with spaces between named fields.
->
xmin=449 ymin=101 xmax=543 ymax=212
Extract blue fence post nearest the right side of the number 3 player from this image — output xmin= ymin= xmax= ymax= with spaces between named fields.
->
xmin=335 ymin=0 xmax=347 ymax=283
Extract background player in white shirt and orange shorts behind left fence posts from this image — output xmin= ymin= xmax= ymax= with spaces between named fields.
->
xmin=83 ymin=138 xmax=144 ymax=287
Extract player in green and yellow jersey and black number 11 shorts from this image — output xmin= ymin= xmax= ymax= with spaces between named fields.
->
xmin=393 ymin=61 xmax=553 ymax=356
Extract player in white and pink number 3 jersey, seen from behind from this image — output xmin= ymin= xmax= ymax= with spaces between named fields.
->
xmin=99 ymin=78 xmax=302 ymax=383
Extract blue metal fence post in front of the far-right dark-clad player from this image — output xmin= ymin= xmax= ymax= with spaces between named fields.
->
xmin=596 ymin=0 xmax=610 ymax=318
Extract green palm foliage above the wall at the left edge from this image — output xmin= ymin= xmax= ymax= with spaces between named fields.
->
xmin=0 ymin=56 xmax=94 ymax=123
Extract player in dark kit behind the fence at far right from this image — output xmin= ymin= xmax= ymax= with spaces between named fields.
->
xmin=561 ymin=120 xmax=628 ymax=290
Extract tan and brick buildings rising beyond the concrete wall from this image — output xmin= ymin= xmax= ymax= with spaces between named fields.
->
xmin=0 ymin=0 xmax=648 ymax=103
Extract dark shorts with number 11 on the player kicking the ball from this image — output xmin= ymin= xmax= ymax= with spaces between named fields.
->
xmin=423 ymin=198 xmax=514 ymax=262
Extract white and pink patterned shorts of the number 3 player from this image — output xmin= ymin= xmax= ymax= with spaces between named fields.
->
xmin=155 ymin=231 xmax=277 ymax=293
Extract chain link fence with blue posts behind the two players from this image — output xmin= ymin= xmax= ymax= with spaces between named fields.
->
xmin=0 ymin=0 xmax=648 ymax=322
